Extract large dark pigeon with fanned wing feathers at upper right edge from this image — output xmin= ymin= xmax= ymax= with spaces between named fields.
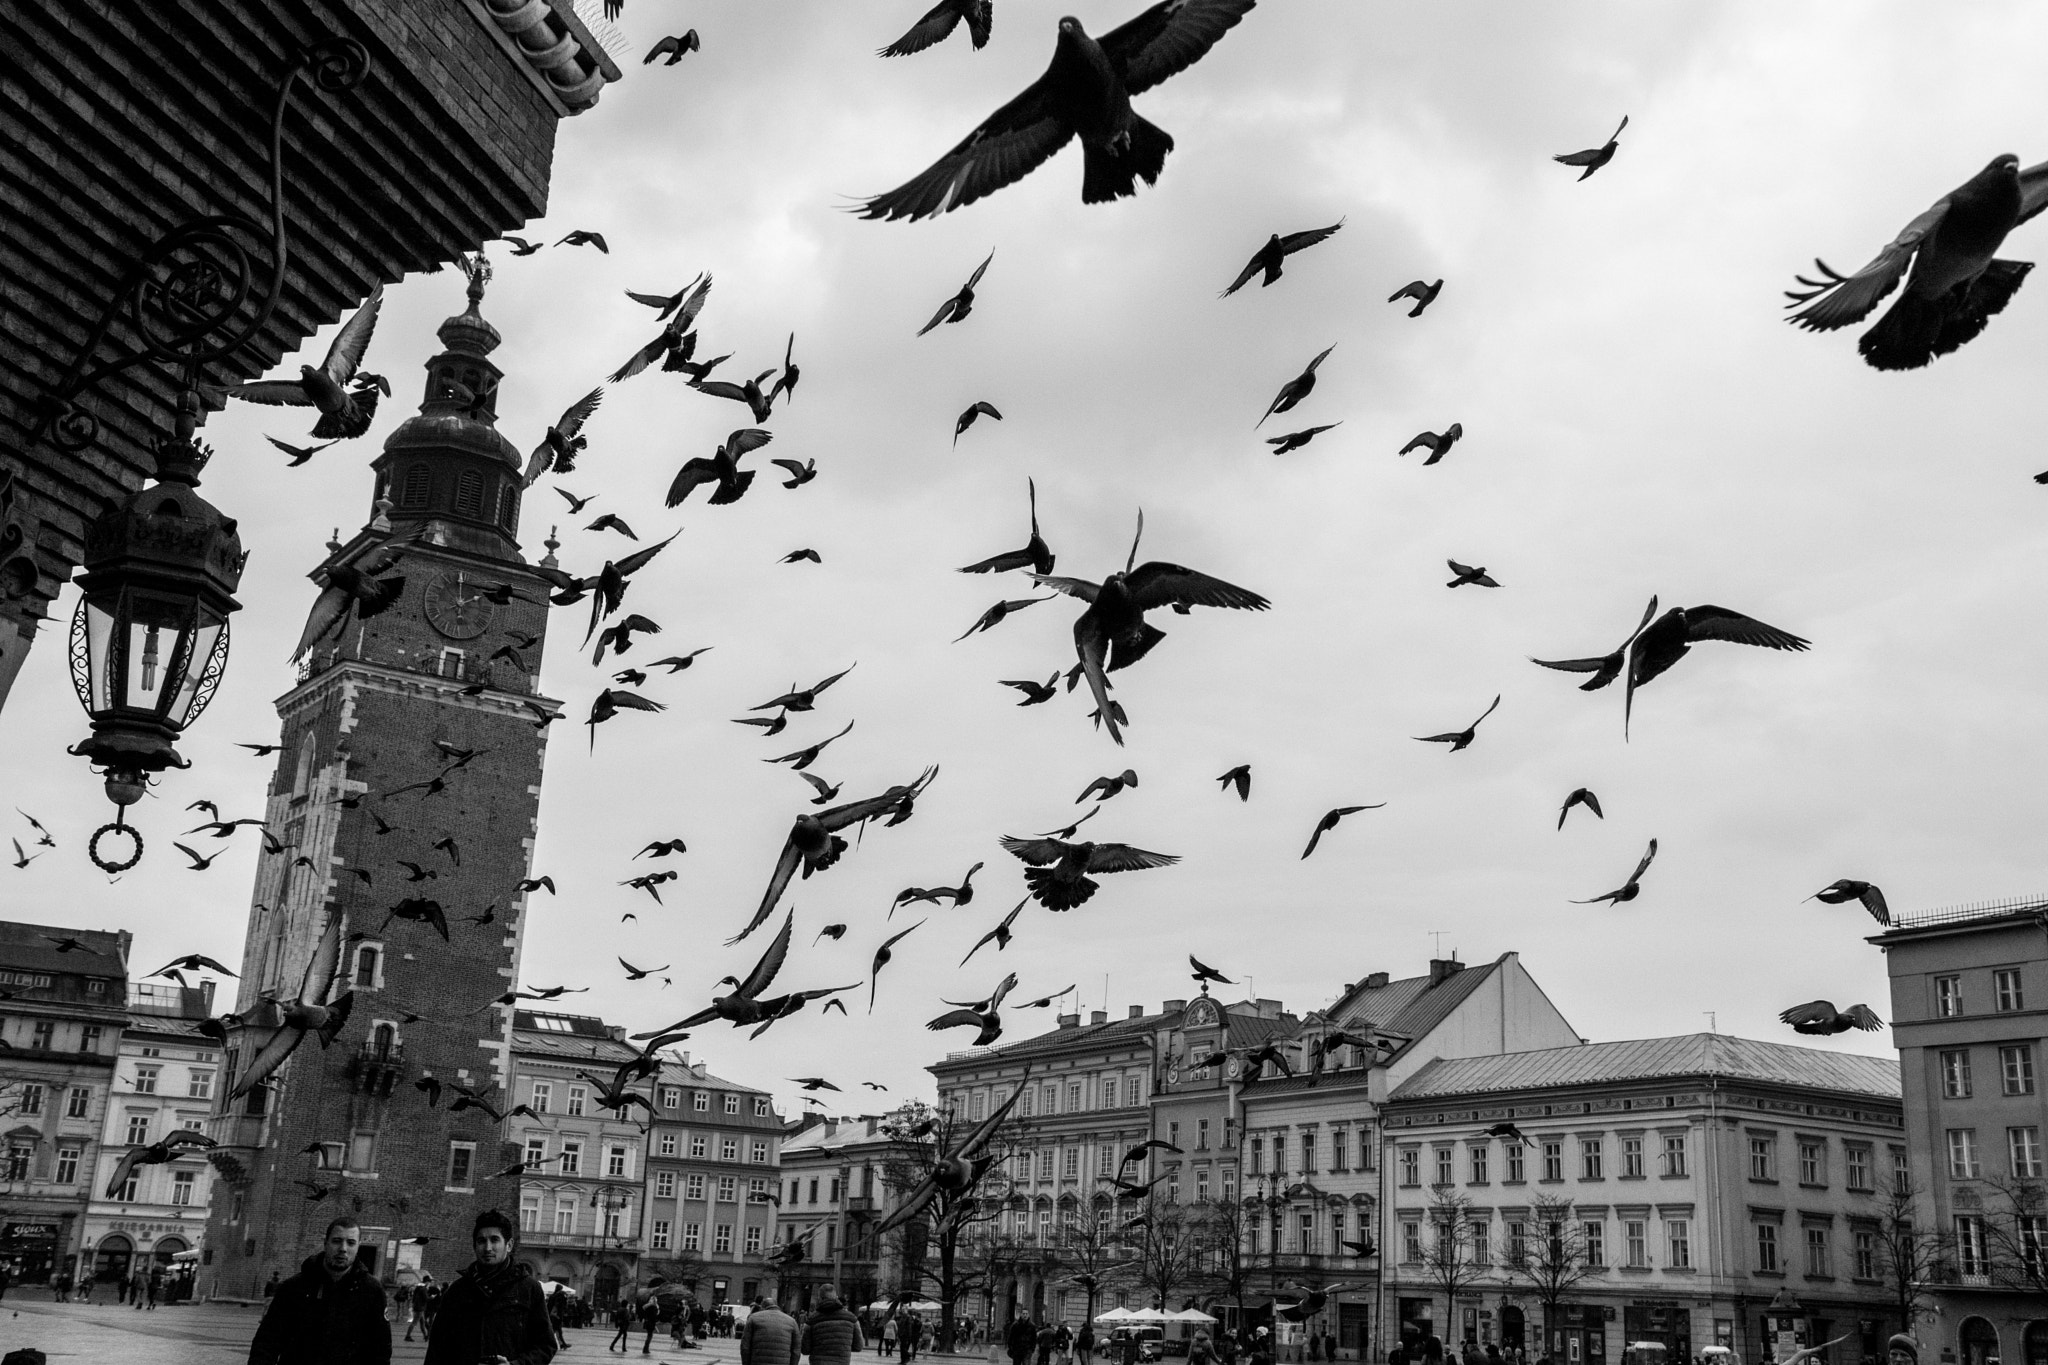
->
xmin=1786 ymin=153 xmax=2048 ymax=370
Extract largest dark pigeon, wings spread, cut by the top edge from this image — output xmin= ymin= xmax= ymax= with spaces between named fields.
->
xmin=860 ymin=0 xmax=1255 ymax=219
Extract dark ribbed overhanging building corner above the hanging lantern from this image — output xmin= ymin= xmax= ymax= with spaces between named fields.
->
xmin=0 ymin=0 xmax=618 ymax=720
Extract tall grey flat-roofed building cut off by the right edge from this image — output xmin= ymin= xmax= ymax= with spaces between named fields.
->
xmin=1870 ymin=900 xmax=2048 ymax=1365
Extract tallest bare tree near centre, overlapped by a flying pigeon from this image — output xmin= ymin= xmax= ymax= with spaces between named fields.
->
xmin=883 ymin=1103 xmax=1012 ymax=1351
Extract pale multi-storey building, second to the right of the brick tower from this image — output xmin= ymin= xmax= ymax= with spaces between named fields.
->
xmin=643 ymin=1052 xmax=784 ymax=1304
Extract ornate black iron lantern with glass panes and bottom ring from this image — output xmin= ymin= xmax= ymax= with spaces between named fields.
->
xmin=72 ymin=417 xmax=248 ymax=872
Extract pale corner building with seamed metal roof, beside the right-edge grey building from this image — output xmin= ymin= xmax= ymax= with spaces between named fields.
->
xmin=1378 ymin=1033 xmax=1905 ymax=1365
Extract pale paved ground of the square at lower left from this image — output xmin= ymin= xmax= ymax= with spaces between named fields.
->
xmin=0 ymin=1293 xmax=987 ymax=1365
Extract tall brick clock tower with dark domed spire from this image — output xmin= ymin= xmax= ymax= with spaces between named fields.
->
xmin=201 ymin=258 xmax=559 ymax=1297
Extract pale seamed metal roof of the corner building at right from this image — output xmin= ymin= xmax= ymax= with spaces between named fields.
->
xmin=1389 ymin=1033 xmax=1901 ymax=1103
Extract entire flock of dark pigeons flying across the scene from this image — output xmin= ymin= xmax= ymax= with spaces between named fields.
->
xmin=12 ymin=0 xmax=2048 ymax=1211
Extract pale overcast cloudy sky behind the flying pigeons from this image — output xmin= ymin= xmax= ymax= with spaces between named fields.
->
xmin=0 ymin=0 xmax=2048 ymax=1109
